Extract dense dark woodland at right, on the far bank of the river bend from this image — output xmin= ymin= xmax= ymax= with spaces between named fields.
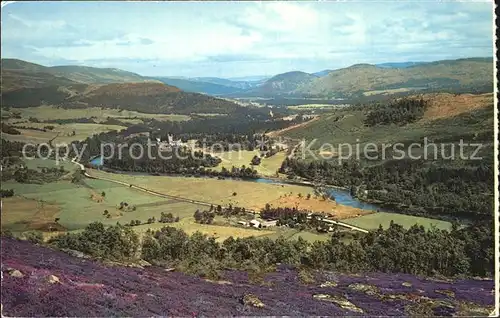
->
xmin=280 ymin=158 xmax=494 ymax=218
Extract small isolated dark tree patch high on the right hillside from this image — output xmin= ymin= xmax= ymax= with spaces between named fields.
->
xmin=365 ymin=98 xmax=427 ymax=126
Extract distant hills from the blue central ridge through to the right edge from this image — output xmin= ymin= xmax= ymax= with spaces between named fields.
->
xmin=151 ymin=58 xmax=493 ymax=98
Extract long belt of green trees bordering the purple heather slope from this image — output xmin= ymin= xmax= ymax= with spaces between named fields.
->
xmin=51 ymin=222 xmax=494 ymax=276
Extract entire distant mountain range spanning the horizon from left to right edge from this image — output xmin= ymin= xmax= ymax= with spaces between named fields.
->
xmin=2 ymin=58 xmax=493 ymax=102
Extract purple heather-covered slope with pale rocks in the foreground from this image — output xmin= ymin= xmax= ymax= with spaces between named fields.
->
xmin=1 ymin=238 xmax=494 ymax=317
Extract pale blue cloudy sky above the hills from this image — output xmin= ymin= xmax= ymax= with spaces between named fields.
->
xmin=1 ymin=1 xmax=493 ymax=78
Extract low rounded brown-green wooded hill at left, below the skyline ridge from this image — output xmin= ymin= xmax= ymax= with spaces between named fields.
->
xmin=2 ymin=83 xmax=248 ymax=114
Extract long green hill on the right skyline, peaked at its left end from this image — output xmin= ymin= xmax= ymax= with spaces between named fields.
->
xmin=292 ymin=58 xmax=493 ymax=96
